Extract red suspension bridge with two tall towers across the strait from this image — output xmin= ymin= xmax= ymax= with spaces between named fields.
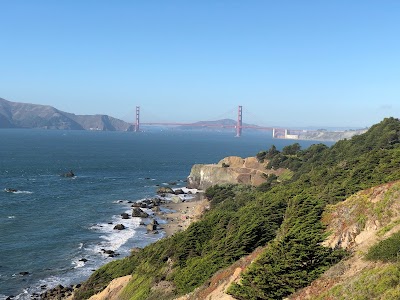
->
xmin=134 ymin=105 xmax=302 ymax=139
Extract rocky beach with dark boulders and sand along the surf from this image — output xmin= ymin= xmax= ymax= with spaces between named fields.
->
xmin=38 ymin=187 xmax=209 ymax=300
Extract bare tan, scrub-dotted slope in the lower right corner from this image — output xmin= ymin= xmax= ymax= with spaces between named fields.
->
xmin=289 ymin=181 xmax=400 ymax=300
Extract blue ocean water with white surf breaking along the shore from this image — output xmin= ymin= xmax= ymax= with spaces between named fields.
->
xmin=0 ymin=129 xmax=322 ymax=299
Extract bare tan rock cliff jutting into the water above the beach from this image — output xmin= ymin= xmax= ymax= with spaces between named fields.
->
xmin=188 ymin=156 xmax=284 ymax=189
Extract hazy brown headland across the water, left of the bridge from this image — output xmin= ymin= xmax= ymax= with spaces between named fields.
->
xmin=0 ymin=98 xmax=133 ymax=131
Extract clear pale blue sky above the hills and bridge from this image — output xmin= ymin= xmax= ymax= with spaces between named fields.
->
xmin=0 ymin=0 xmax=400 ymax=127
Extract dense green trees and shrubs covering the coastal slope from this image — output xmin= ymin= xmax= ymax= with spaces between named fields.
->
xmin=75 ymin=118 xmax=400 ymax=299
